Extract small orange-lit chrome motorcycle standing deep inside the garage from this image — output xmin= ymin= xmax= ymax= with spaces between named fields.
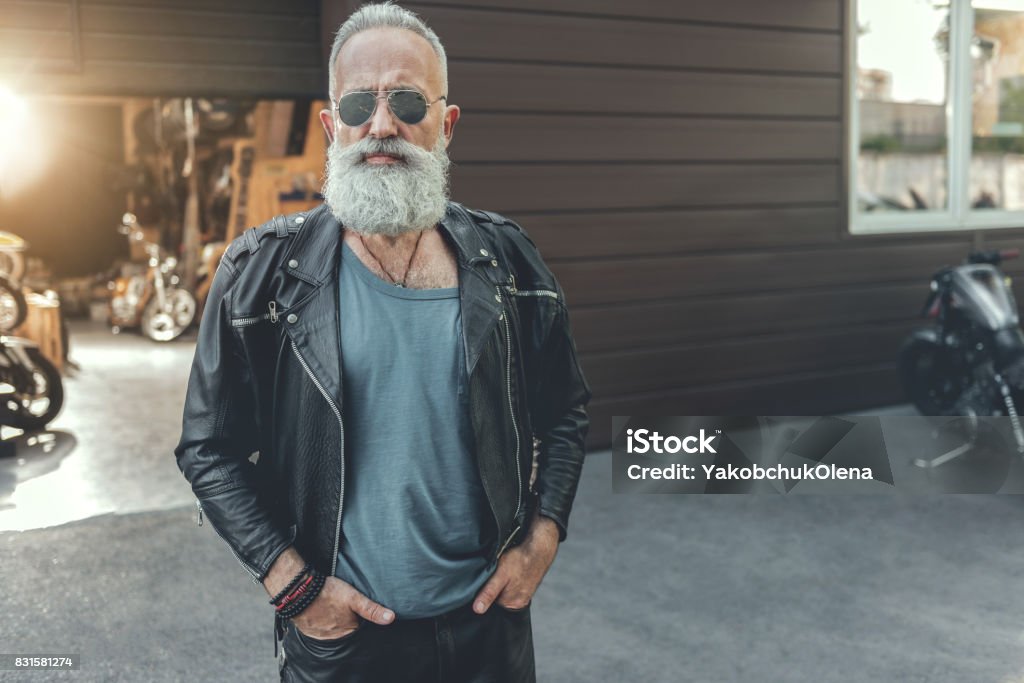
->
xmin=108 ymin=213 xmax=196 ymax=341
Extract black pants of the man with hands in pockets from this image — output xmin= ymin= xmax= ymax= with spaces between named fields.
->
xmin=281 ymin=603 xmax=537 ymax=683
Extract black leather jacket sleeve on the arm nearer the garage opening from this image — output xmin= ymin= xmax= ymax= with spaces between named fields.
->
xmin=174 ymin=254 xmax=294 ymax=582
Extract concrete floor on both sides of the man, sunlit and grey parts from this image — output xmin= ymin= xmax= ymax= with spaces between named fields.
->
xmin=0 ymin=326 xmax=1024 ymax=683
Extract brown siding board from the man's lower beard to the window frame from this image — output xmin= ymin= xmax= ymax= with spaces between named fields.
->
xmin=453 ymin=164 xmax=840 ymax=211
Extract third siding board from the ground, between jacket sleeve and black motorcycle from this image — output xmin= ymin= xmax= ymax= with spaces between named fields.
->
xmin=569 ymin=282 xmax=928 ymax=354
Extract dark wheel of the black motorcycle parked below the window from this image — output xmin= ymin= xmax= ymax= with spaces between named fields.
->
xmin=899 ymin=338 xmax=974 ymax=415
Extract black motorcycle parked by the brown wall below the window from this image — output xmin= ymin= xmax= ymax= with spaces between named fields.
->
xmin=899 ymin=250 xmax=1024 ymax=449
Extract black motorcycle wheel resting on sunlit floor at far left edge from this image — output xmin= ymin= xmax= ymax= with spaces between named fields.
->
xmin=0 ymin=348 xmax=63 ymax=432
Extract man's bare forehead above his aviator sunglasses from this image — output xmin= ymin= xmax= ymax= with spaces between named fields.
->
xmin=336 ymin=29 xmax=440 ymax=93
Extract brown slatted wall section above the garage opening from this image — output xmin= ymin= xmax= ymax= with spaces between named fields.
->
xmin=0 ymin=0 xmax=326 ymax=97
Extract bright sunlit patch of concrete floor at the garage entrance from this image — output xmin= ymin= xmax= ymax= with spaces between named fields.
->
xmin=0 ymin=321 xmax=196 ymax=530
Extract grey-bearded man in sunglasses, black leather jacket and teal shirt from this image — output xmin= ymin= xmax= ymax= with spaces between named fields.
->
xmin=175 ymin=4 xmax=590 ymax=683
